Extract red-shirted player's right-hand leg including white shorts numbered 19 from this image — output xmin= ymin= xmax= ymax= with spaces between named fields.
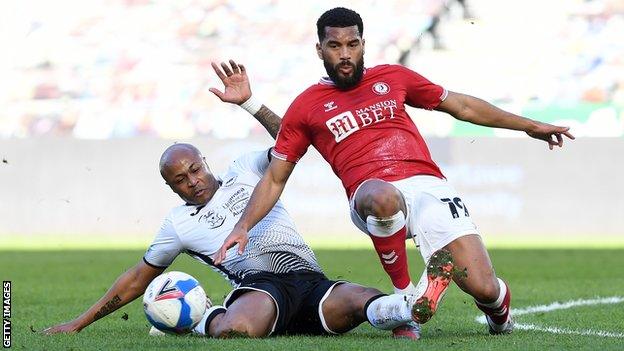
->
xmin=404 ymin=176 xmax=512 ymax=336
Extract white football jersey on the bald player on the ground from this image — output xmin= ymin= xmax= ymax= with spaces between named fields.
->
xmin=143 ymin=150 xmax=322 ymax=286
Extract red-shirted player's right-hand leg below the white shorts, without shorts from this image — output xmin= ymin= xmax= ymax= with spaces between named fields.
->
xmin=446 ymin=234 xmax=513 ymax=334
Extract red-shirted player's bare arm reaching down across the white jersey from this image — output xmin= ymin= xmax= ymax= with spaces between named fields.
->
xmin=214 ymin=157 xmax=295 ymax=264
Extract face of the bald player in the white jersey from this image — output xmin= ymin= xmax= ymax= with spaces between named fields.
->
xmin=162 ymin=150 xmax=216 ymax=205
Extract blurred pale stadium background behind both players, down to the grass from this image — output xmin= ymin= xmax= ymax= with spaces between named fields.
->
xmin=0 ymin=0 xmax=624 ymax=248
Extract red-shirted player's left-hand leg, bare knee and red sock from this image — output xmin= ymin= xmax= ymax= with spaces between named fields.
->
xmin=351 ymin=179 xmax=414 ymax=293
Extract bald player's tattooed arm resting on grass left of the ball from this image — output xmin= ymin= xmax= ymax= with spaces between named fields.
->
xmin=43 ymin=261 xmax=164 ymax=334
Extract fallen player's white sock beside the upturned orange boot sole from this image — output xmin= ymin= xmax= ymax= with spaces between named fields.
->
xmin=366 ymin=294 xmax=415 ymax=330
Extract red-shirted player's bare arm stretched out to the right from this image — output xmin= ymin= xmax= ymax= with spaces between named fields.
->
xmin=436 ymin=91 xmax=574 ymax=150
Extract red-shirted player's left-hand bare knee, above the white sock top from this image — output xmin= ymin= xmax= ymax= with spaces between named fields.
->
xmin=355 ymin=180 xmax=405 ymax=218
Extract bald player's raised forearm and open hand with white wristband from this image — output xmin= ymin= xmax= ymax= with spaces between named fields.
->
xmin=209 ymin=60 xmax=282 ymax=139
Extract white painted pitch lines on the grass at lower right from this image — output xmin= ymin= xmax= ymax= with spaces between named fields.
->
xmin=476 ymin=296 xmax=624 ymax=338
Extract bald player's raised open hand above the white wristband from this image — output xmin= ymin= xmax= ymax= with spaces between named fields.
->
xmin=208 ymin=60 xmax=251 ymax=105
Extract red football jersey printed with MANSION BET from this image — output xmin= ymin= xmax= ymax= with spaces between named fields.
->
xmin=272 ymin=65 xmax=447 ymax=197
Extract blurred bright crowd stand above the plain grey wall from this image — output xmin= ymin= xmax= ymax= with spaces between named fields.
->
xmin=0 ymin=0 xmax=624 ymax=139
